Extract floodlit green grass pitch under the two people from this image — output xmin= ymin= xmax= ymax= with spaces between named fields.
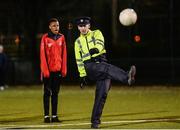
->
xmin=0 ymin=85 xmax=180 ymax=129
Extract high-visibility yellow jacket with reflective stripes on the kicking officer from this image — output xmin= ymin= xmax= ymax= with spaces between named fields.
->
xmin=74 ymin=30 xmax=106 ymax=77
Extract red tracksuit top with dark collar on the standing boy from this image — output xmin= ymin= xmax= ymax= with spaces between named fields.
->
xmin=40 ymin=32 xmax=67 ymax=78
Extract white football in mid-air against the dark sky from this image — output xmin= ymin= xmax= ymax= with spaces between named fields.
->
xmin=119 ymin=8 xmax=137 ymax=26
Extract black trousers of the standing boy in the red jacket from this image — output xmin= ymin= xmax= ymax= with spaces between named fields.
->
xmin=43 ymin=72 xmax=61 ymax=116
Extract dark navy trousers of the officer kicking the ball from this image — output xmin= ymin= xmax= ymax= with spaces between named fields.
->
xmin=85 ymin=62 xmax=128 ymax=124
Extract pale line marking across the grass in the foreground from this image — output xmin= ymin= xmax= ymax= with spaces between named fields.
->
xmin=0 ymin=118 xmax=180 ymax=129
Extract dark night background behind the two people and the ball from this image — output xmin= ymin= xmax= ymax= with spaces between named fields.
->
xmin=0 ymin=0 xmax=180 ymax=85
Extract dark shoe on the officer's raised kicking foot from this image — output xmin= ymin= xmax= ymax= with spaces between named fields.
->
xmin=128 ymin=65 xmax=136 ymax=85
